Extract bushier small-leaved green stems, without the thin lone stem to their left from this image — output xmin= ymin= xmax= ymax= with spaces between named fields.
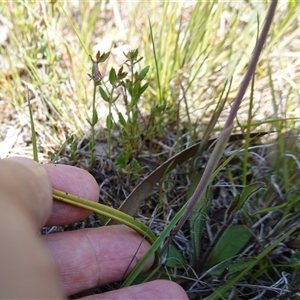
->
xmin=99 ymin=49 xmax=149 ymax=174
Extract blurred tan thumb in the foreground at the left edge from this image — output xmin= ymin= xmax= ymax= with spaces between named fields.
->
xmin=0 ymin=158 xmax=61 ymax=299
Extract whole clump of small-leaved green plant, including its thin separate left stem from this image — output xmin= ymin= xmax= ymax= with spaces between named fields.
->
xmin=89 ymin=49 xmax=153 ymax=178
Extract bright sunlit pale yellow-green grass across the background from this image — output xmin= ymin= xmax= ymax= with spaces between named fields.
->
xmin=1 ymin=1 xmax=299 ymax=141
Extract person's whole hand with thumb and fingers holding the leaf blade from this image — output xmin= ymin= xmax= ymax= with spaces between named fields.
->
xmin=0 ymin=158 xmax=188 ymax=300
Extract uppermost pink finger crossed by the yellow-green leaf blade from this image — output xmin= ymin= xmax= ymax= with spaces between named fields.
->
xmin=43 ymin=165 xmax=99 ymax=226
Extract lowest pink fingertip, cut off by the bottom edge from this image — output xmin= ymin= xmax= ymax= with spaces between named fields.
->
xmin=81 ymin=280 xmax=188 ymax=300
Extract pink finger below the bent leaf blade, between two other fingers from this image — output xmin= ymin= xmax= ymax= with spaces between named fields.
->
xmin=43 ymin=225 xmax=153 ymax=295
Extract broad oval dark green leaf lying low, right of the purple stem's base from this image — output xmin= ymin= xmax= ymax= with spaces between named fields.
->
xmin=206 ymin=225 xmax=252 ymax=268
